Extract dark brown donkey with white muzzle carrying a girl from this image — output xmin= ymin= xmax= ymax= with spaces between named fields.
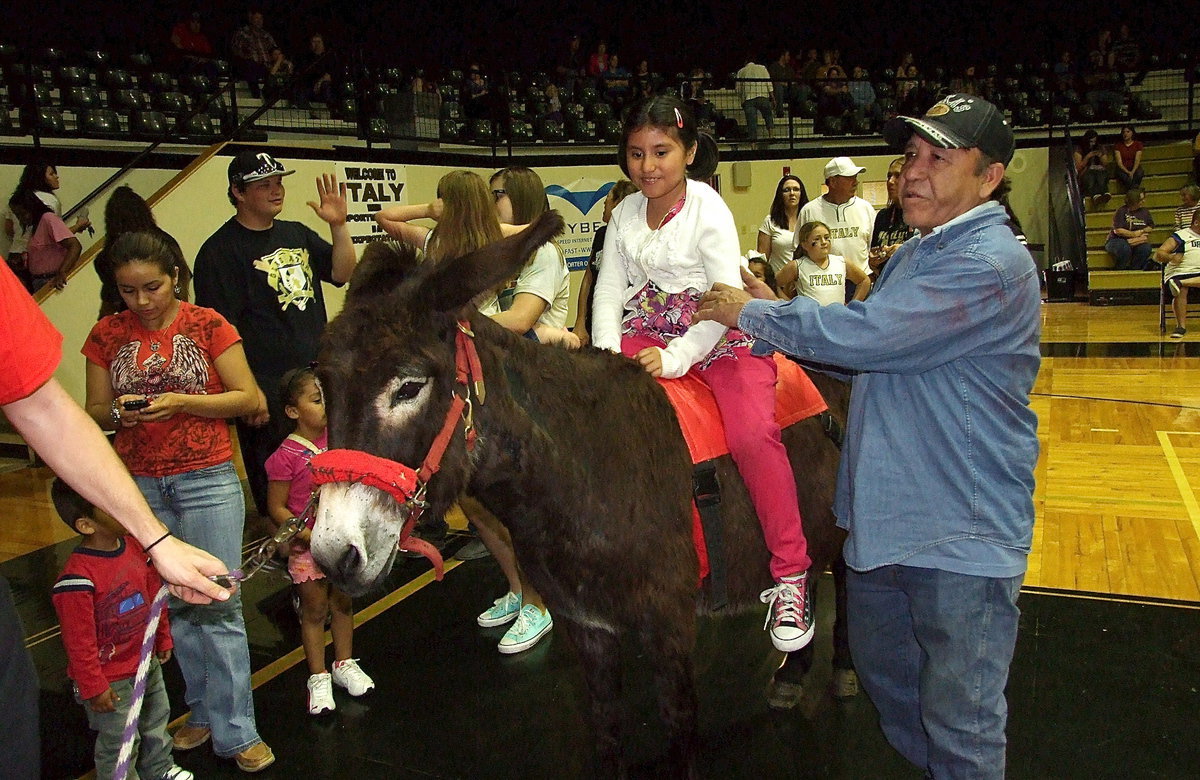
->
xmin=312 ymin=214 xmax=845 ymax=776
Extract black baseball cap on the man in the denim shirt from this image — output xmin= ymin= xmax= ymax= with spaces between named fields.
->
xmin=883 ymin=94 xmax=1015 ymax=166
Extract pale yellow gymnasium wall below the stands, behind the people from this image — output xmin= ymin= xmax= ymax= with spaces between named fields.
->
xmin=32 ymin=142 xmax=1048 ymax=402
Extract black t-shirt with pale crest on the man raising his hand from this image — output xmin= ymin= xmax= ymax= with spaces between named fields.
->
xmin=193 ymin=218 xmax=334 ymax=379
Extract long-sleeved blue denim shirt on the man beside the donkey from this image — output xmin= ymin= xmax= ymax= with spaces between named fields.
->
xmin=738 ymin=202 xmax=1040 ymax=577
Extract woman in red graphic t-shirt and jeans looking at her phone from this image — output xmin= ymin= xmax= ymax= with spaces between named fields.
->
xmin=83 ymin=233 xmax=274 ymax=769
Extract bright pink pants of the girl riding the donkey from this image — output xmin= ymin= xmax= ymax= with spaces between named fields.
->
xmin=620 ymin=335 xmax=812 ymax=580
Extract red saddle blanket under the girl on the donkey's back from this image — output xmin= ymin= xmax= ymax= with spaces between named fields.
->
xmin=659 ymin=353 xmax=829 ymax=580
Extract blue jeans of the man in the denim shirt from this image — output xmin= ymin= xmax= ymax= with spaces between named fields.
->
xmin=846 ymin=565 xmax=1024 ymax=779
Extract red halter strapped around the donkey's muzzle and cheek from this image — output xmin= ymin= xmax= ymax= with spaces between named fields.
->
xmin=308 ymin=319 xmax=485 ymax=580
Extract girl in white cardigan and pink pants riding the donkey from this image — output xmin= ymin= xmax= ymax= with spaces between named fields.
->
xmin=592 ymin=96 xmax=814 ymax=652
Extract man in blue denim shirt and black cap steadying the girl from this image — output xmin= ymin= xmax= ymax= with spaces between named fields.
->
xmin=698 ymin=95 xmax=1040 ymax=778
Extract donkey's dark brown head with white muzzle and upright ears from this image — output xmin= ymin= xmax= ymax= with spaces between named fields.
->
xmin=312 ymin=212 xmax=563 ymax=594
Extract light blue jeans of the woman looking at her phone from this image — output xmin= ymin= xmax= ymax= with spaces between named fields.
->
xmin=133 ymin=462 xmax=262 ymax=758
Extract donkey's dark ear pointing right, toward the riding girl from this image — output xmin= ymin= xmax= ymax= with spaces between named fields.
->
xmin=418 ymin=211 xmax=563 ymax=312
